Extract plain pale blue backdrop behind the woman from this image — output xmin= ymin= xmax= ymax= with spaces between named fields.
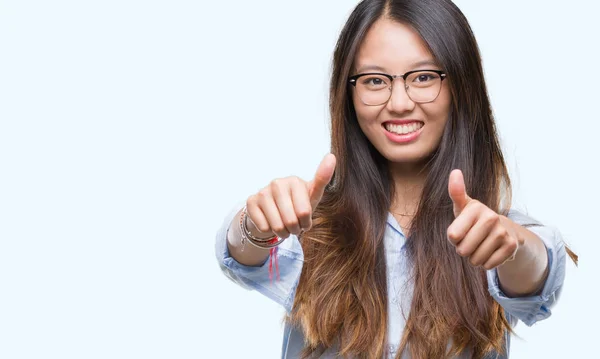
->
xmin=0 ymin=0 xmax=600 ymax=359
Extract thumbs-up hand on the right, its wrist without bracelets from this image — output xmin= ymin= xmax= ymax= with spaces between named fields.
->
xmin=447 ymin=170 xmax=523 ymax=270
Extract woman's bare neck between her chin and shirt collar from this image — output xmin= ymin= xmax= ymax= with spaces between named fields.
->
xmin=389 ymin=163 xmax=427 ymax=217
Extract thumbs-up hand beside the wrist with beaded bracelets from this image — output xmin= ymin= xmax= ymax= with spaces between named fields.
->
xmin=246 ymin=154 xmax=336 ymax=238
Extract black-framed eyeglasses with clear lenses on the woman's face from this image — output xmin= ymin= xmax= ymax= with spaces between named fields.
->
xmin=348 ymin=70 xmax=446 ymax=106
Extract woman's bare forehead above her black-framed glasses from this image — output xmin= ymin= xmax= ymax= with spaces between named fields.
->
xmin=354 ymin=18 xmax=434 ymax=73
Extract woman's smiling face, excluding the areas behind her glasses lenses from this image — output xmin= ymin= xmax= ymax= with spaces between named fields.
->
xmin=351 ymin=19 xmax=451 ymax=164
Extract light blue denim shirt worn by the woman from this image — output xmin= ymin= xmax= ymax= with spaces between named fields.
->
xmin=216 ymin=204 xmax=566 ymax=359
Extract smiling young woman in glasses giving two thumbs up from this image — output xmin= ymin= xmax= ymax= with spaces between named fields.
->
xmin=217 ymin=0 xmax=575 ymax=358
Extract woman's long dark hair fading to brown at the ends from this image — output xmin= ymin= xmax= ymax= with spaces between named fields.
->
xmin=290 ymin=0 xmax=568 ymax=358
